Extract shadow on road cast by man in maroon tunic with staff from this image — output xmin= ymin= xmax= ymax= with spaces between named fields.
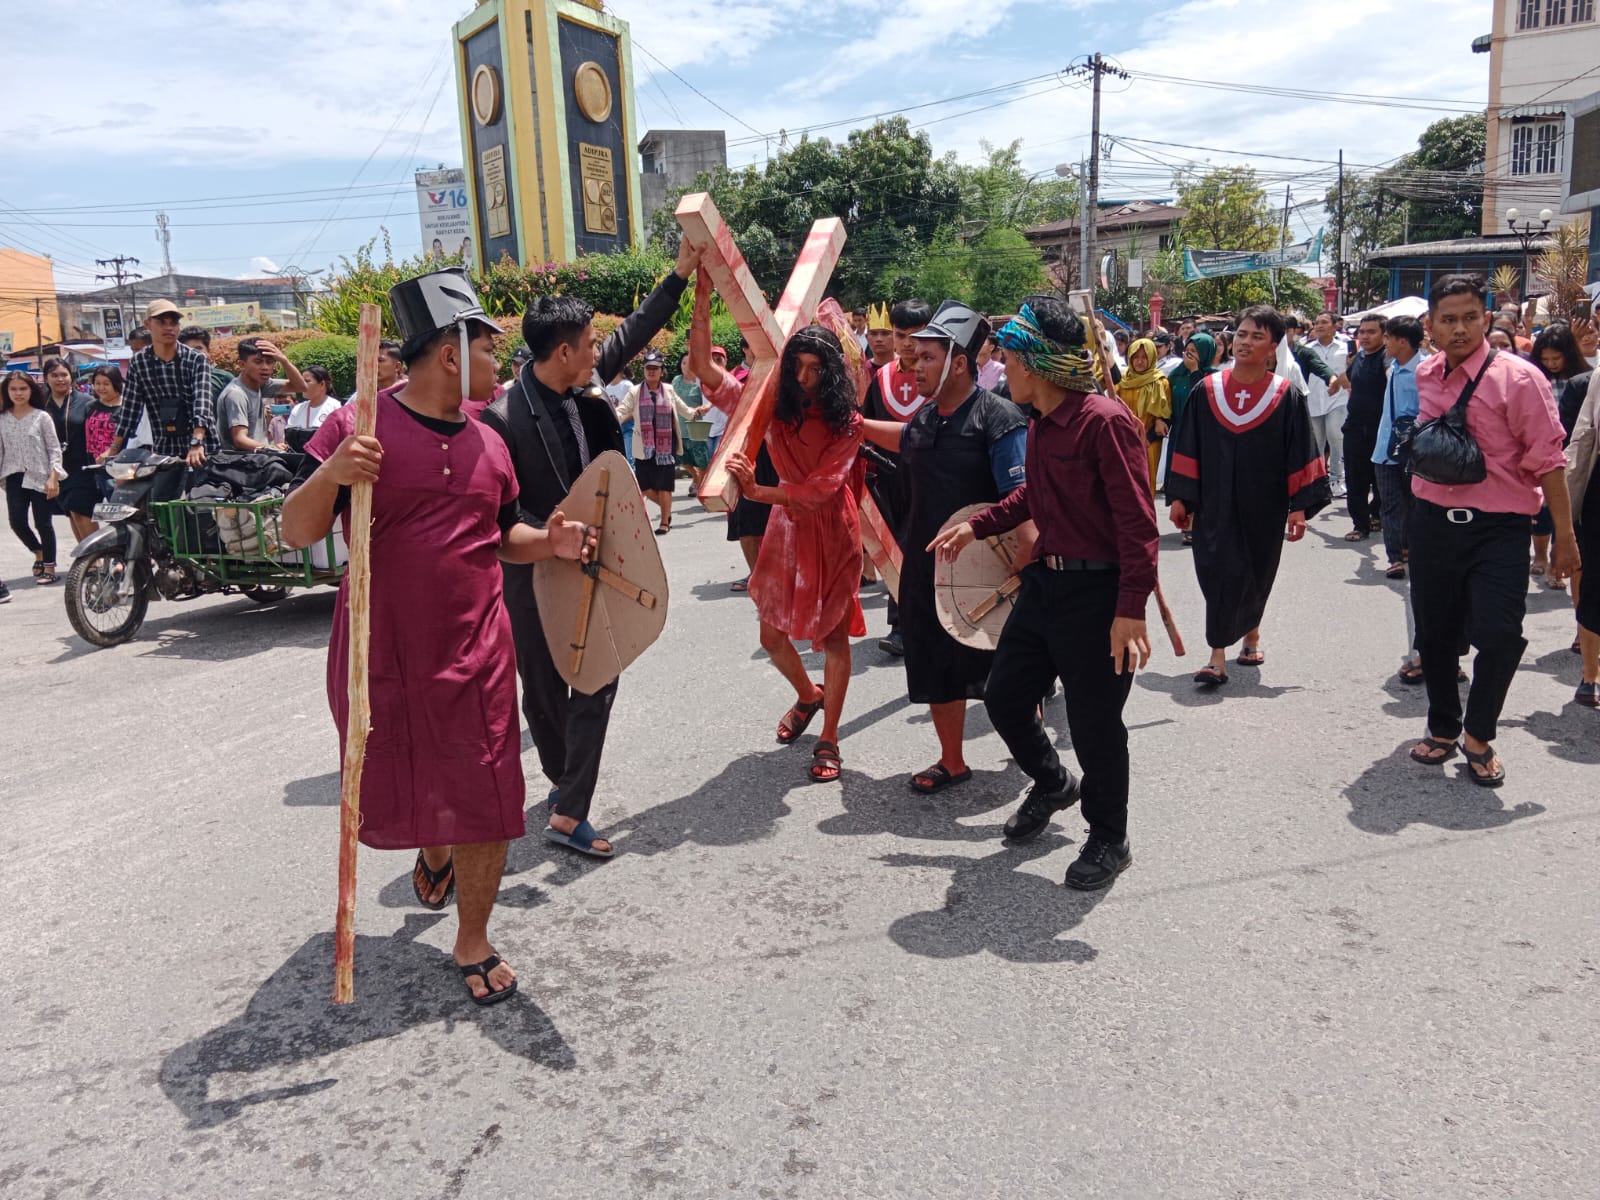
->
xmin=160 ymin=915 xmax=578 ymax=1128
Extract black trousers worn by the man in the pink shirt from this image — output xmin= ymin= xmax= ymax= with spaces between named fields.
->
xmin=1411 ymin=499 xmax=1531 ymax=742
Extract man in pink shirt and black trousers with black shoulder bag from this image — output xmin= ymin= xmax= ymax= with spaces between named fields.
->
xmin=1411 ymin=275 xmax=1579 ymax=787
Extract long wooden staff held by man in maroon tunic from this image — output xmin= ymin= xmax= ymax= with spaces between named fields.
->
xmin=333 ymin=304 xmax=382 ymax=1005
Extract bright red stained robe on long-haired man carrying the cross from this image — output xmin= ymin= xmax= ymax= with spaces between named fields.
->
xmin=706 ymin=374 xmax=867 ymax=642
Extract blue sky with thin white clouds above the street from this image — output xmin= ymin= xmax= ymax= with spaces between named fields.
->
xmin=0 ymin=0 xmax=1491 ymax=291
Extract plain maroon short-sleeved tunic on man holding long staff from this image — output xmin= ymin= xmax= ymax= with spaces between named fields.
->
xmin=306 ymin=384 xmax=525 ymax=850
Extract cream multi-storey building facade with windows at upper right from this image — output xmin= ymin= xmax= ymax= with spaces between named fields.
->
xmin=1474 ymin=0 xmax=1600 ymax=235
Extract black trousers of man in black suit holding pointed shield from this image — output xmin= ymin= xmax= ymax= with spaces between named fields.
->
xmin=506 ymin=566 xmax=616 ymax=821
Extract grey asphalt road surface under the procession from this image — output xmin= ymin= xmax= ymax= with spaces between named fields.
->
xmin=0 ymin=489 xmax=1600 ymax=1200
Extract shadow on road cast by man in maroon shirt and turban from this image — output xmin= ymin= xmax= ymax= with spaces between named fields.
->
xmin=878 ymin=830 xmax=1107 ymax=963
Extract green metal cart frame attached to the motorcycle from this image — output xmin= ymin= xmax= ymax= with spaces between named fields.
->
xmin=150 ymin=496 xmax=344 ymax=590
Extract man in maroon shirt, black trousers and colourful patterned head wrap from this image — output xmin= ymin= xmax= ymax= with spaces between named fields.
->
xmin=928 ymin=296 xmax=1158 ymax=891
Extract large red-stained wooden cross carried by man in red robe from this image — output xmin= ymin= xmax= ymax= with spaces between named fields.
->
xmin=677 ymin=192 xmax=845 ymax=512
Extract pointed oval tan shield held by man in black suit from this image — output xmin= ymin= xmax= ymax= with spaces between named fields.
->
xmin=533 ymin=450 xmax=667 ymax=694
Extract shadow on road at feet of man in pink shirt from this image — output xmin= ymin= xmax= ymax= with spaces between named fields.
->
xmin=1344 ymin=742 xmax=1544 ymax=834
